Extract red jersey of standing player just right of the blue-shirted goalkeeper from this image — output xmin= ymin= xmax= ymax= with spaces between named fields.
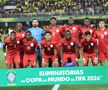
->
xmin=47 ymin=25 xmax=63 ymax=43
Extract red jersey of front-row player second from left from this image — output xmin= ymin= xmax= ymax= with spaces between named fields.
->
xmin=22 ymin=38 xmax=38 ymax=54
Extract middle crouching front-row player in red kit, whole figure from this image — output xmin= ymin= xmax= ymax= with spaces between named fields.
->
xmin=41 ymin=31 xmax=58 ymax=67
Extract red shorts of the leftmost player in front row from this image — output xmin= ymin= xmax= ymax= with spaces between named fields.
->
xmin=6 ymin=53 xmax=20 ymax=64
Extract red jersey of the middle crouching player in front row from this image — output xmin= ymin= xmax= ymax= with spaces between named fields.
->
xmin=41 ymin=40 xmax=56 ymax=55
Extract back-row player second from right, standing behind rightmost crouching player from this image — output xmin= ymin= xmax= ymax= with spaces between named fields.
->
xmin=81 ymin=18 xmax=96 ymax=38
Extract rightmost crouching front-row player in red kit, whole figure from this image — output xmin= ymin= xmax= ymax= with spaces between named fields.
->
xmin=80 ymin=31 xmax=98 ymax=66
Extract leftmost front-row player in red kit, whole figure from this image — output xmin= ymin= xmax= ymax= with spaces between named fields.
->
xmin=3 ymin=32 xmax=21 ymax=68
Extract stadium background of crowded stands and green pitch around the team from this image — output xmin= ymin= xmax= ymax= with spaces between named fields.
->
xmin=0 ymin=0 xmax=108 ymax=90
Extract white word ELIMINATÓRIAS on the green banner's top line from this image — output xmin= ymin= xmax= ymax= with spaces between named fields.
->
xmin=39 ymin=70 xmax=84 ymax=76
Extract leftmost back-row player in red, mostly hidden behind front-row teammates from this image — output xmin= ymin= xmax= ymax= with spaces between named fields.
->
xmin=14 ymin=23 xmax=26 ymax=68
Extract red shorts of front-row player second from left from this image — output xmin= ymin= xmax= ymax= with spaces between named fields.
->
xmin=23 ymin=54 xmax=37 ymax=67
